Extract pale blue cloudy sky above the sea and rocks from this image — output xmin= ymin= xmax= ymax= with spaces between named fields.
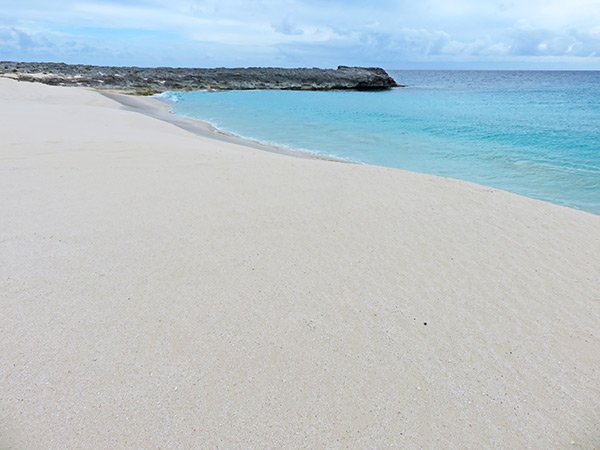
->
xmin=0 ymin=0 xmax=600 ymax=70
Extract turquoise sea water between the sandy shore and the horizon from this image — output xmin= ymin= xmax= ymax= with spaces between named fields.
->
xmin=161 ymin=71 xmax=600 ymax=214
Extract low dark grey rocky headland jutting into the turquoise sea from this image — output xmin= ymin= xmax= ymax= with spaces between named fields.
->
xmin=0 ymin=62 xmax=399 ymax=95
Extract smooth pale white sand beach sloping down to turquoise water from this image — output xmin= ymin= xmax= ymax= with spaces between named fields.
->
xmin=0 ymin=79 xmax=600 ymax=449
